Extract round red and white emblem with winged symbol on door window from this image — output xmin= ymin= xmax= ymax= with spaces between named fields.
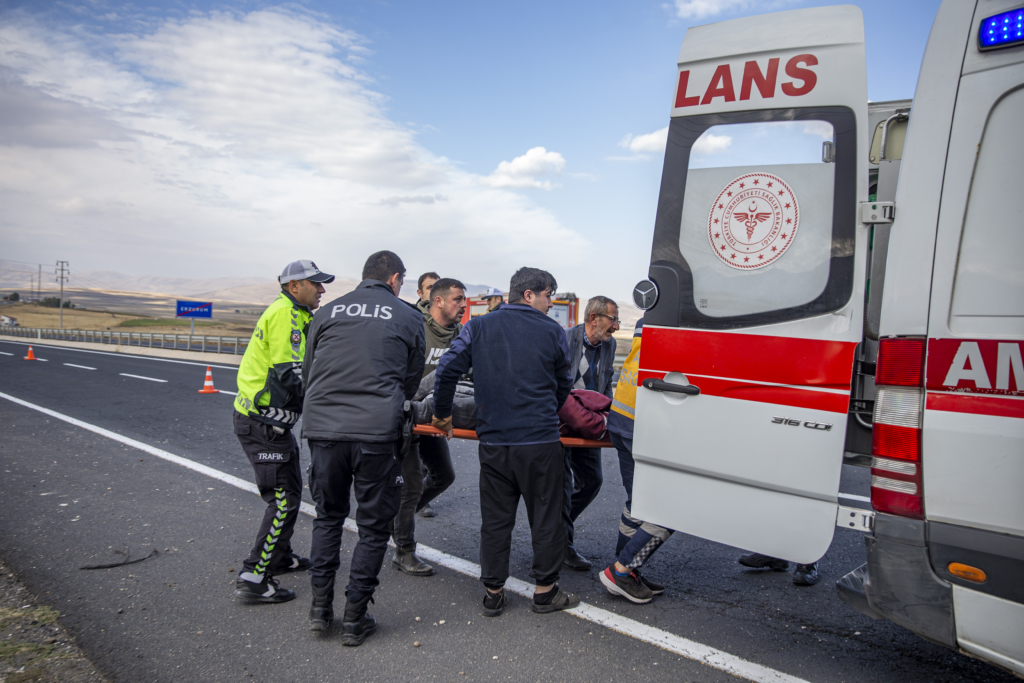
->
xmin=708 ymin=173 xmax=800 ymax=270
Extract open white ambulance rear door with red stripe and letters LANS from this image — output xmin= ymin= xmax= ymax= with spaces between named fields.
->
xmin=633 ymin=6 xmax=869 ymax=562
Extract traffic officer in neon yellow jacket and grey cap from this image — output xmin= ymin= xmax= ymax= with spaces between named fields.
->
xmin=233 ymin=261 xmax=334 ymax=602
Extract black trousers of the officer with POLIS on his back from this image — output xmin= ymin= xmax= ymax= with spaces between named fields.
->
xmin=309 ymin=440 xmax=402 ymax=602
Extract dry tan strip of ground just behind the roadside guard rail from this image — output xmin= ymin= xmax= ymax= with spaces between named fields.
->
xmin=0 ymin=303 xmax=255 ymax=337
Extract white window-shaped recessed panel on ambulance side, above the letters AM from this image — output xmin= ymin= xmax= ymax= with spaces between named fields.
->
xmin=949 ymin=89 xmax=1024 ymax=338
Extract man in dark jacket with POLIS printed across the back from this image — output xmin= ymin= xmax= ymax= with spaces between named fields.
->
xmin=302 ymin=251 xmax=424 ymax=645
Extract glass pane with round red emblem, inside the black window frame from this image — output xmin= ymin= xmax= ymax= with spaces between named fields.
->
xmin=679 ymin=121 xmax=836 ymax=317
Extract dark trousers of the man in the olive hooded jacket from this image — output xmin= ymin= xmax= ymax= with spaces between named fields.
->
xmin=392 ymin=435 xmax=455 ymax=548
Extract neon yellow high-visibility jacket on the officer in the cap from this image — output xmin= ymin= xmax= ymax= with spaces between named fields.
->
xmin=234 ymin=292 xmax=313 ymax=428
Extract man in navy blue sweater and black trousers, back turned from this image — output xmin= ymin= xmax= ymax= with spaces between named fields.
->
xmin=433 ymin=268 xmax=580 ymax=616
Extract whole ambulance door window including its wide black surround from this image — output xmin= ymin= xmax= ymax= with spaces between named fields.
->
xmin=647 ymin=106 xmax=857 ymax=330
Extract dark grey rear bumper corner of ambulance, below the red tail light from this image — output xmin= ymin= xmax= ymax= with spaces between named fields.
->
xmin=836 ymin=513 xmax=956 ymax=649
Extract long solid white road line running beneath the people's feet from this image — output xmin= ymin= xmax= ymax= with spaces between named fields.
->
xmin=0 ymin=392 xmax=807 ymax=683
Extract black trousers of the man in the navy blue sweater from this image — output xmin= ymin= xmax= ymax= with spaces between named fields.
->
xmin=479 ymin=441 xmax=565 ymax=590
